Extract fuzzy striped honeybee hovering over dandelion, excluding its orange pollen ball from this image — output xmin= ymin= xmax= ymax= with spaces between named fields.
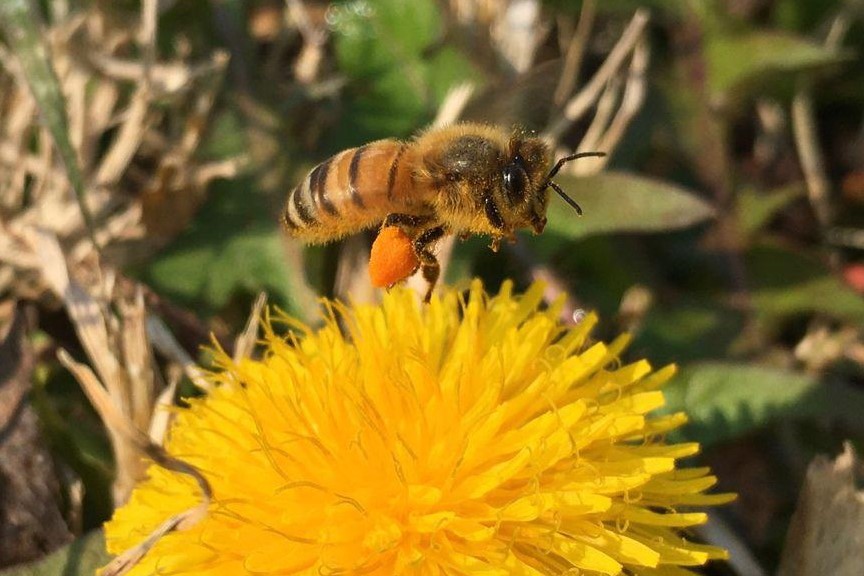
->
xmin=281 ymin=123 xmax=604 ymax=301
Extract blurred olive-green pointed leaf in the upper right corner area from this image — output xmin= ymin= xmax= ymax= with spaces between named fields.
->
xmin=705 ymin=30 xmax=844 ymax=94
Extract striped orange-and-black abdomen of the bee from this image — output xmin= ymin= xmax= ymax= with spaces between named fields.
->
xmin=281 ymin=140 xmax=418 ymax=242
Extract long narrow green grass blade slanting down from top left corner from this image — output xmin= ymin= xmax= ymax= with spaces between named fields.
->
xmin=0 ymin=0 xmax=95 ymax=238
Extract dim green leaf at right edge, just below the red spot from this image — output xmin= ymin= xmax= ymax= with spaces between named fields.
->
xmin=745 ymin=244 xmax=864 ymax=322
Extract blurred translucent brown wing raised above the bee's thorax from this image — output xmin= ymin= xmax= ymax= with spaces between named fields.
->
xmin=462 ymin=59 xmax=563 ymax=132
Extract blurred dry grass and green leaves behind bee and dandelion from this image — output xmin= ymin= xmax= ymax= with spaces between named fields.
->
xmin=0 ymin=0 xmax=864 ymax=575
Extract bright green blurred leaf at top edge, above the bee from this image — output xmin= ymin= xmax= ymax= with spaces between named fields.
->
xmin=330 ymin=0 xmax=478 ymax=147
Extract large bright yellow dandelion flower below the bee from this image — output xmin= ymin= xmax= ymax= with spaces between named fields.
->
xmin=106 ymin=282 xmax=730 ymax=576
